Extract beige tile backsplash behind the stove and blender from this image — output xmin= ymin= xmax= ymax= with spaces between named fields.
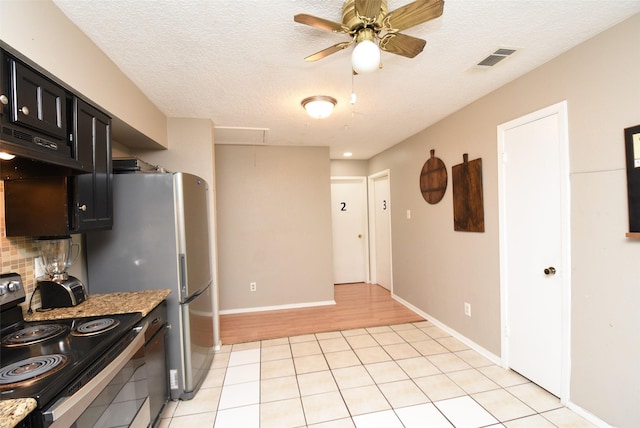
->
xmin=0 ymin=181 xmax=40 ymax=308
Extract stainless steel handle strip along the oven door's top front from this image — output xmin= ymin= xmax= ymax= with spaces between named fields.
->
xmin=44 ymin=322 xmax=149 ymax=428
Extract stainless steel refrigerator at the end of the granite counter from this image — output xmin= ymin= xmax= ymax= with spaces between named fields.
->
xmin=85 ymin=172 xmax=217 ymax=400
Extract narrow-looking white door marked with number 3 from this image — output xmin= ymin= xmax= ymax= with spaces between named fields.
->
xmin=369 ymin=171 xmax=392 ymax=290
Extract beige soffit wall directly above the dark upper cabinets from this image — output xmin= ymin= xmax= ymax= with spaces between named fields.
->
xmin=0 ymin=0 xmax=167 ymax=148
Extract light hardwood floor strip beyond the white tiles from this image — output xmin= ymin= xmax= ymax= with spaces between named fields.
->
xmin=220 ymin=283 xmax=424 ymax=345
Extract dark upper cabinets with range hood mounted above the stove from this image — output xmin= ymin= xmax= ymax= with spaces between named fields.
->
xmin=0 ymin=45 xmax=113 ymax=236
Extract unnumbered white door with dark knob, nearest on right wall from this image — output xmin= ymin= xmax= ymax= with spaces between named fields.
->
xmin=498 ymin=103 xmax=570 ymax=396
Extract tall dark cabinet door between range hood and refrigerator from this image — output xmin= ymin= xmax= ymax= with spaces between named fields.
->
xmin=71 ymin=98 xmax=113 ymax=233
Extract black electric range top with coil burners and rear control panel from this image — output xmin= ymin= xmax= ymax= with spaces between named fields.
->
xmin=0 ymin=274 xmax=142 ymax=426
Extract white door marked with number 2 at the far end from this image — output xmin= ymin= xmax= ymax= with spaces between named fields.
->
xmin=331 ymin=177 xmax=368 ymax=284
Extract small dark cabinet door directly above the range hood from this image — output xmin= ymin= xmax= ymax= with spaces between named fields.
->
xmin=10 ymin=60 xmax=67 ymax=140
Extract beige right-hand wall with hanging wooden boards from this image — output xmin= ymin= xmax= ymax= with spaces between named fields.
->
xmin=369 ymin=15 xmax=640 ymax=427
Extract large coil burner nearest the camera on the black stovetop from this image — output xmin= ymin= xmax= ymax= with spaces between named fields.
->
xmin=0 ymin=354 xmax=69 ymax=389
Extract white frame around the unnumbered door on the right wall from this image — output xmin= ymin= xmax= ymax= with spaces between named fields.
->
xmin=497 ymin=101 xmax=571 ymax=404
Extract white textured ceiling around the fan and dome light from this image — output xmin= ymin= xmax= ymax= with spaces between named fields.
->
xmin=53 ymin=0 xmax=640 ymax=159
